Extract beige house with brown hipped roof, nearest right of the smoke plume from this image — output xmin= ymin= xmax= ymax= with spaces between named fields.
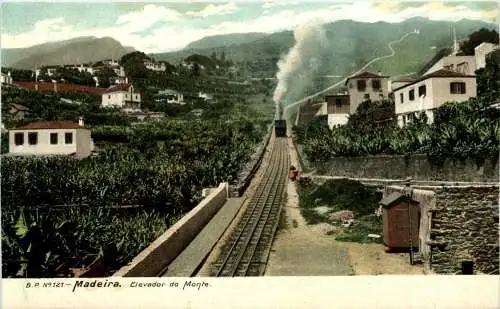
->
xmin=345 ymin=72 xmax=389 ymax=114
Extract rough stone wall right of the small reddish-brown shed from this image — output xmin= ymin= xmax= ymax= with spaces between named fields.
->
xmin=385 ymin=185 xmax=499 ymax=274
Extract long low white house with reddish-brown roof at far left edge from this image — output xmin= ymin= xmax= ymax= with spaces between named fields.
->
xmin=9 ymin=119 xmax=94 ymax=157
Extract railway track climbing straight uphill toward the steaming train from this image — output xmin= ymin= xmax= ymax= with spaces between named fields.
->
xmin=211 ymin=138 xmax=289 ymax=277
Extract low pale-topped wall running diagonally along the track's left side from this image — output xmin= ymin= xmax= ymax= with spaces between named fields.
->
xmin=113 ymin=183 xmax=228 ymax=277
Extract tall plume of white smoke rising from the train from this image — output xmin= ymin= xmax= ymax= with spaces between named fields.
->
xmin=273 ymin=25 xmax=328 ymax=119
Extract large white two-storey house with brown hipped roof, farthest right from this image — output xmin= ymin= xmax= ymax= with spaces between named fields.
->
xmin=394 ymin=69 xmax=476 ymax=127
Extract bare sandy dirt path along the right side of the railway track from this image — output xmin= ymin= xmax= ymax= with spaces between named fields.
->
xmin=265 ymin=132 xmax=424 ymax=276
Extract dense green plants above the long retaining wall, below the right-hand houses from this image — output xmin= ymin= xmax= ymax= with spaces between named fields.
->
xmin=294 ymin=97 xmax=500 ymax=162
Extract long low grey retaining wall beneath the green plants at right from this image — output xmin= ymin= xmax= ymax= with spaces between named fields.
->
xmin=314 ymin=155 xmax=499 ymax=182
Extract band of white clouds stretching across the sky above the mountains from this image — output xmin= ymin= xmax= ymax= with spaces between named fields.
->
xmin=1 ymin=1 xmax=498 ymax=53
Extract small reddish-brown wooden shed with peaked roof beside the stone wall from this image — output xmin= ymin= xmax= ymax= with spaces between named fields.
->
xmin=380 ymin=192 xmax=420 ymax=251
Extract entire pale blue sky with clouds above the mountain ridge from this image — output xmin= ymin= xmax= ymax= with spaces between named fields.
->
xmin=1 ymin=0 xmax=499 ymax=52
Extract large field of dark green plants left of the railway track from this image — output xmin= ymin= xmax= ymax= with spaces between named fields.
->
xmin=1 ymin=106 xmax=269 ymax=277
